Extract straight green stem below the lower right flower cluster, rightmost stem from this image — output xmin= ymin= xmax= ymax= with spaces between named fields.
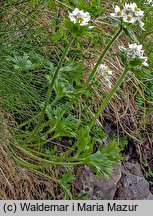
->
xmin=89 ymin=67 xmax=129 ymax=129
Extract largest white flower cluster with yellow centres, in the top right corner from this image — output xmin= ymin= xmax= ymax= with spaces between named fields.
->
xmin=111 ymin=3 xmax=144 ymax=30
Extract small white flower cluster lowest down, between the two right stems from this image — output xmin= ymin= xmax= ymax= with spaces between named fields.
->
xmin=97 ymin=64 xmax=112 ymax=88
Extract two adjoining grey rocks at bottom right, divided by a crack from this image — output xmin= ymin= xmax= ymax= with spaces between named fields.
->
xmin=73 ymin=162 xmax=153 ymax=200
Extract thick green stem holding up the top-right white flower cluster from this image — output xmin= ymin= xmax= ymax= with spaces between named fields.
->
xmin=83 ymin=26 xmax=122 ymax=89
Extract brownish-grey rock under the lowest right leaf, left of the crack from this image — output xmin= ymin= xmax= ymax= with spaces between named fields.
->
xmin=73 ymin=164 xmax=121 ymax=200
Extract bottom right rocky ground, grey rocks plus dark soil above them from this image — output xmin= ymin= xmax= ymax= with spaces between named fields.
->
xmin=72 ymin=122 xmax=153 ymax=200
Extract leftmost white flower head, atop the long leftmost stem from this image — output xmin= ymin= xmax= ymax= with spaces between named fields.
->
xmin=69 ymin=8 xmax=91 ymax=26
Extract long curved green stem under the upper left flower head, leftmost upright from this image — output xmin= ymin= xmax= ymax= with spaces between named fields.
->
xmin=26 ymin=38 xmax=74 ymax=142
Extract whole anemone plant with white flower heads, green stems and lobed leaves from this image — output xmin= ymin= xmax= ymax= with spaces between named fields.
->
xmin=2 ymin=3 xmax=148 ymax=198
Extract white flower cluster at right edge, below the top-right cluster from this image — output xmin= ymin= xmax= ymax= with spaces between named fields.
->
xmin=119 ymin=43 xmax=148 ymax=67
